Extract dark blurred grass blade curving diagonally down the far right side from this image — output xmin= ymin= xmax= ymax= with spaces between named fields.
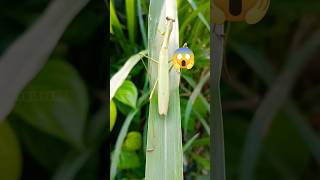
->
xmin=240 ymin=29 xmax=320 ymax=180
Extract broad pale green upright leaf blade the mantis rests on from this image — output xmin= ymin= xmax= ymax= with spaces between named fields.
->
xmin=145 ymin=0 xmax=183 ymax=180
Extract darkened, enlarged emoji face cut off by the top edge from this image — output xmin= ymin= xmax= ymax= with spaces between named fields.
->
xmin=213 ymin=0 xmax=270 ymax=24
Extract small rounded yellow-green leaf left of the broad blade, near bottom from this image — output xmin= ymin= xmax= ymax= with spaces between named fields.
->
xmin=123 ymin=131 xmax=142 ymax=151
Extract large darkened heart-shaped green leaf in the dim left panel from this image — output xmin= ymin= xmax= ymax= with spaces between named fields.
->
xmin=13 ymin=60 xmax=88 ymax=147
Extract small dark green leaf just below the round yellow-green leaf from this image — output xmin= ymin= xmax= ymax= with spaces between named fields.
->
xmin=118 ymin=150 xmax=141 ymax=169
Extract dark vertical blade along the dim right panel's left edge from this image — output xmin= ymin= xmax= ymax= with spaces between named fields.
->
xmin=210 ymin=23 xmax=226 ymax=180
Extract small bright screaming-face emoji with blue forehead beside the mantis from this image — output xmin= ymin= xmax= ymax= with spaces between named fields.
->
xmin=173 ymin=44 xmax=194 ymax=70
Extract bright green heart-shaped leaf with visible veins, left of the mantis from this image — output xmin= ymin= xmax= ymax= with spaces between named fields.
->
xmin=115 ymin=81 xmax=138 ymax=108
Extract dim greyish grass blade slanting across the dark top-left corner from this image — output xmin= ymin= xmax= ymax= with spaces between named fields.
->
xmin=0 ymin=0 xmax=89 ymax=121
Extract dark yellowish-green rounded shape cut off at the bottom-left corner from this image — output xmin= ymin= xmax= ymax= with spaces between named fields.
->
xmin=0 ymin=122 xmax=22 ymax=180
